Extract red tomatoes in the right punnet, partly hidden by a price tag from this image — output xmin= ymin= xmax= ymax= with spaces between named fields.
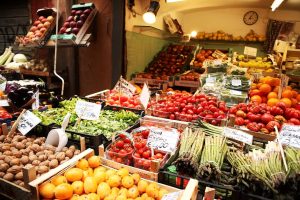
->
xmin=133 ymin=129 xmax=165 ymax=170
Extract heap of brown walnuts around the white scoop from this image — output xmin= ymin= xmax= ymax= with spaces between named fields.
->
xmin=0 ymin=134 xmax=80 ymax=187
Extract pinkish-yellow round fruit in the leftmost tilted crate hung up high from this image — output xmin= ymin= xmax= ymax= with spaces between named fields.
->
xmin=24 ymin=16 xmax=54 ymax=43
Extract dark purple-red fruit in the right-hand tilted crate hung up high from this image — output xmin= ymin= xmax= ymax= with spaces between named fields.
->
xmin=59 ymin=8 xmax=92 ymax=35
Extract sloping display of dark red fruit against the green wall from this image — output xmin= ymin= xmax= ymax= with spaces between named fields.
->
xmin=137 ymin=44 xmax=196 ymax=78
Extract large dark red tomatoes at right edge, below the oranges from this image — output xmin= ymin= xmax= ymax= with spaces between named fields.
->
xmin=229 ymin=102 xmax=300 ymax=134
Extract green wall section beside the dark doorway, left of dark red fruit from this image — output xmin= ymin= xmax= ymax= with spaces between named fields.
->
xmin=126 ymin=31 xmax=170 ymax=80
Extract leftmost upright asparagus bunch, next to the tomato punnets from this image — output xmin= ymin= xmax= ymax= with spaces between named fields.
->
xmin=174 ymin=127 xmax=205 ymax=175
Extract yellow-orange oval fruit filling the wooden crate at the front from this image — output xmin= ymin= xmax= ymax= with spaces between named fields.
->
xmin=39 ymin=156 xmax=169 ymax=200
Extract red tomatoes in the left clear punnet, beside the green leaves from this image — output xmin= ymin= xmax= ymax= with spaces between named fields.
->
xmin=106 ymin=134 xmax=133 ymax=165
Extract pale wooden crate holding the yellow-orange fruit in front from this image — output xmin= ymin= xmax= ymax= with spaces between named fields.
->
xmin=29 ymin=149 xmax=198 ymax=200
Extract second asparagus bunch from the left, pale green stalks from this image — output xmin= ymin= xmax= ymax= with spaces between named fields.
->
xmin=197 ymin=135 xmax=228 ymax=180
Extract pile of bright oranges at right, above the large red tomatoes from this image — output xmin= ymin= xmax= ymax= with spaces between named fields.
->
xmin=249 ymin=76 xmax=300 ymax=108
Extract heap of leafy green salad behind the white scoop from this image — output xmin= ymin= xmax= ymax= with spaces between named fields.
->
xmin=34 ymin=98 xmax=139 ymax=139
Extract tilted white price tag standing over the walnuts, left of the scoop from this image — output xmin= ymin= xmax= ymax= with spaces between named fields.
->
xmin=18 ymin=110 xmax=41 ymax=135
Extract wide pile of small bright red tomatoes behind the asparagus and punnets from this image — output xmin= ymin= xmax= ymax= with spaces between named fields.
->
xmin=150 ymin=93 xmax=228 ymax=125
